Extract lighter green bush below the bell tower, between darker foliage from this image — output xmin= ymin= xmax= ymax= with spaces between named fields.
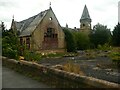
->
xmin=73 ymin=32 xmax=90 ymax=50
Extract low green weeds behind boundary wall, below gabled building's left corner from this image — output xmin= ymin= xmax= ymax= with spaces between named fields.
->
xmin=23 ymin=50 xmax=42 ymax=61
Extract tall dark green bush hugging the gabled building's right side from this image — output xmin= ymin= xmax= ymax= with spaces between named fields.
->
xmin=63 ymin=29 xmax=76 ymax=52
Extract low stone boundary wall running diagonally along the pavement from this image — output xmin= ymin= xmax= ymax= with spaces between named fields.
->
xmin=2 ymin=57 xmax=120 ymax=88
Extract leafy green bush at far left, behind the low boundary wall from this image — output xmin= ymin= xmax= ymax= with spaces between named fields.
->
xmin=2 ymin=27 xmax=19 ymax=60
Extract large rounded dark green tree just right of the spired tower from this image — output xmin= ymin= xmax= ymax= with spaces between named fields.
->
xmin=89 ymin=23 xmax=111 ymax=47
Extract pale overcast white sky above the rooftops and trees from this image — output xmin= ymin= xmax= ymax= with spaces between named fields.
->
xmin=0 ymin=0 xmax=119 ymax=30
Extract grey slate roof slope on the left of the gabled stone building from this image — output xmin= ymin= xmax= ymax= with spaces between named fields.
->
xmin=16 ymin=10 xmax=48 ymax=37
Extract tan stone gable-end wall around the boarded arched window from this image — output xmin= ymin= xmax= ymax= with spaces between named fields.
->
xmin=32 ymin=9 xmax=65 ymax=51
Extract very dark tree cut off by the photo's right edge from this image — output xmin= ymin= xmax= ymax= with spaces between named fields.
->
xmin=112 ymin=23 xmax=120 ymax=46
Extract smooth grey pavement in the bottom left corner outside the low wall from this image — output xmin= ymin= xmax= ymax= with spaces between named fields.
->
xmin=2 ymin=67 xmax=49 ymax=88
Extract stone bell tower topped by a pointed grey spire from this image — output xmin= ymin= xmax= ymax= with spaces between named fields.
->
xmin=80 ymin=5 xmax=92 ymax=34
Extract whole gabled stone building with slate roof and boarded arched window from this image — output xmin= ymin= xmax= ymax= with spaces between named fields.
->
xmin=11 ymin=7 xmax=65 ymax=52
